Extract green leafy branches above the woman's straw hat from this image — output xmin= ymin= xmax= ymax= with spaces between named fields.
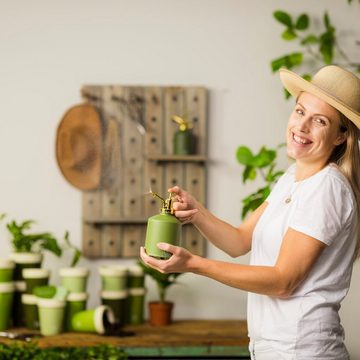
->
xmin=271 ymin=0 xmax=360 ymax=98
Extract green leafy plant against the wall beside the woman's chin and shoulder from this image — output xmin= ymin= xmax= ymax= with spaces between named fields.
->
xmin=236 ymin=144 xmax=284 ymax=219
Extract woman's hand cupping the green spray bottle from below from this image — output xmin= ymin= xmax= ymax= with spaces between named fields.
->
xmin=140 ymin=243 xmax=196 ymax=274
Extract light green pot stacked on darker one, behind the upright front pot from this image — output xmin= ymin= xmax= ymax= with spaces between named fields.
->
xmin=60 ymin=267 xmax=89 ymax=331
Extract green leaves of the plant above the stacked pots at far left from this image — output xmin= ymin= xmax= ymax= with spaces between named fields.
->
xmin=6 ymin=220 xmax=62 ymax=256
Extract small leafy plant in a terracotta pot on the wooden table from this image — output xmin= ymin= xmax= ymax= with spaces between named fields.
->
xmin=139 ymin=261 xmax=181 ymax=326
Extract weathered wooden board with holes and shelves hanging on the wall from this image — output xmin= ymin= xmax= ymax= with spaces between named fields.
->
xmin=82 ymin=85 xmax=207 ymax=258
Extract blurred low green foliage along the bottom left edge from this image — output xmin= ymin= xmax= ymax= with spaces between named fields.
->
xmin=0 ymin=342 xmax=128 ymax=360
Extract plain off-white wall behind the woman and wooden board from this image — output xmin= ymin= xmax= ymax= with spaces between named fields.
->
xmin=0 ymin=0 xmax=360 ymax=359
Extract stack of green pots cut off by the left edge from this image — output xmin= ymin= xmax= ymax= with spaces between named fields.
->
xmin=0 ymin=259 xmax=15 ymax=331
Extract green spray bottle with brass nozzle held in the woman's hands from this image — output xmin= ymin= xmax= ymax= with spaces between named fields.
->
xmin=145 ymin=191 xmax=181 ymax=260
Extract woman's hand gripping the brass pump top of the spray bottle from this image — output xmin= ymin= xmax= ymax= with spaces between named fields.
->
xmin=168 ymin=186 xmax=199 ymax=224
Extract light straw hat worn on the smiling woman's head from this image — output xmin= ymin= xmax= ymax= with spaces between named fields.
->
xmin=279 ymin=65 xmax=360 ymax=129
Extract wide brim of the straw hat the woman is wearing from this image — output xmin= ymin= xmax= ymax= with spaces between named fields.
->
xmin=279 ymin=69 xmax=360 ymax=129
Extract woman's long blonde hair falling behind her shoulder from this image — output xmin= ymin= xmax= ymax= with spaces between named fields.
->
xmin=329 ymin=113 xmax=360 ymax=259
